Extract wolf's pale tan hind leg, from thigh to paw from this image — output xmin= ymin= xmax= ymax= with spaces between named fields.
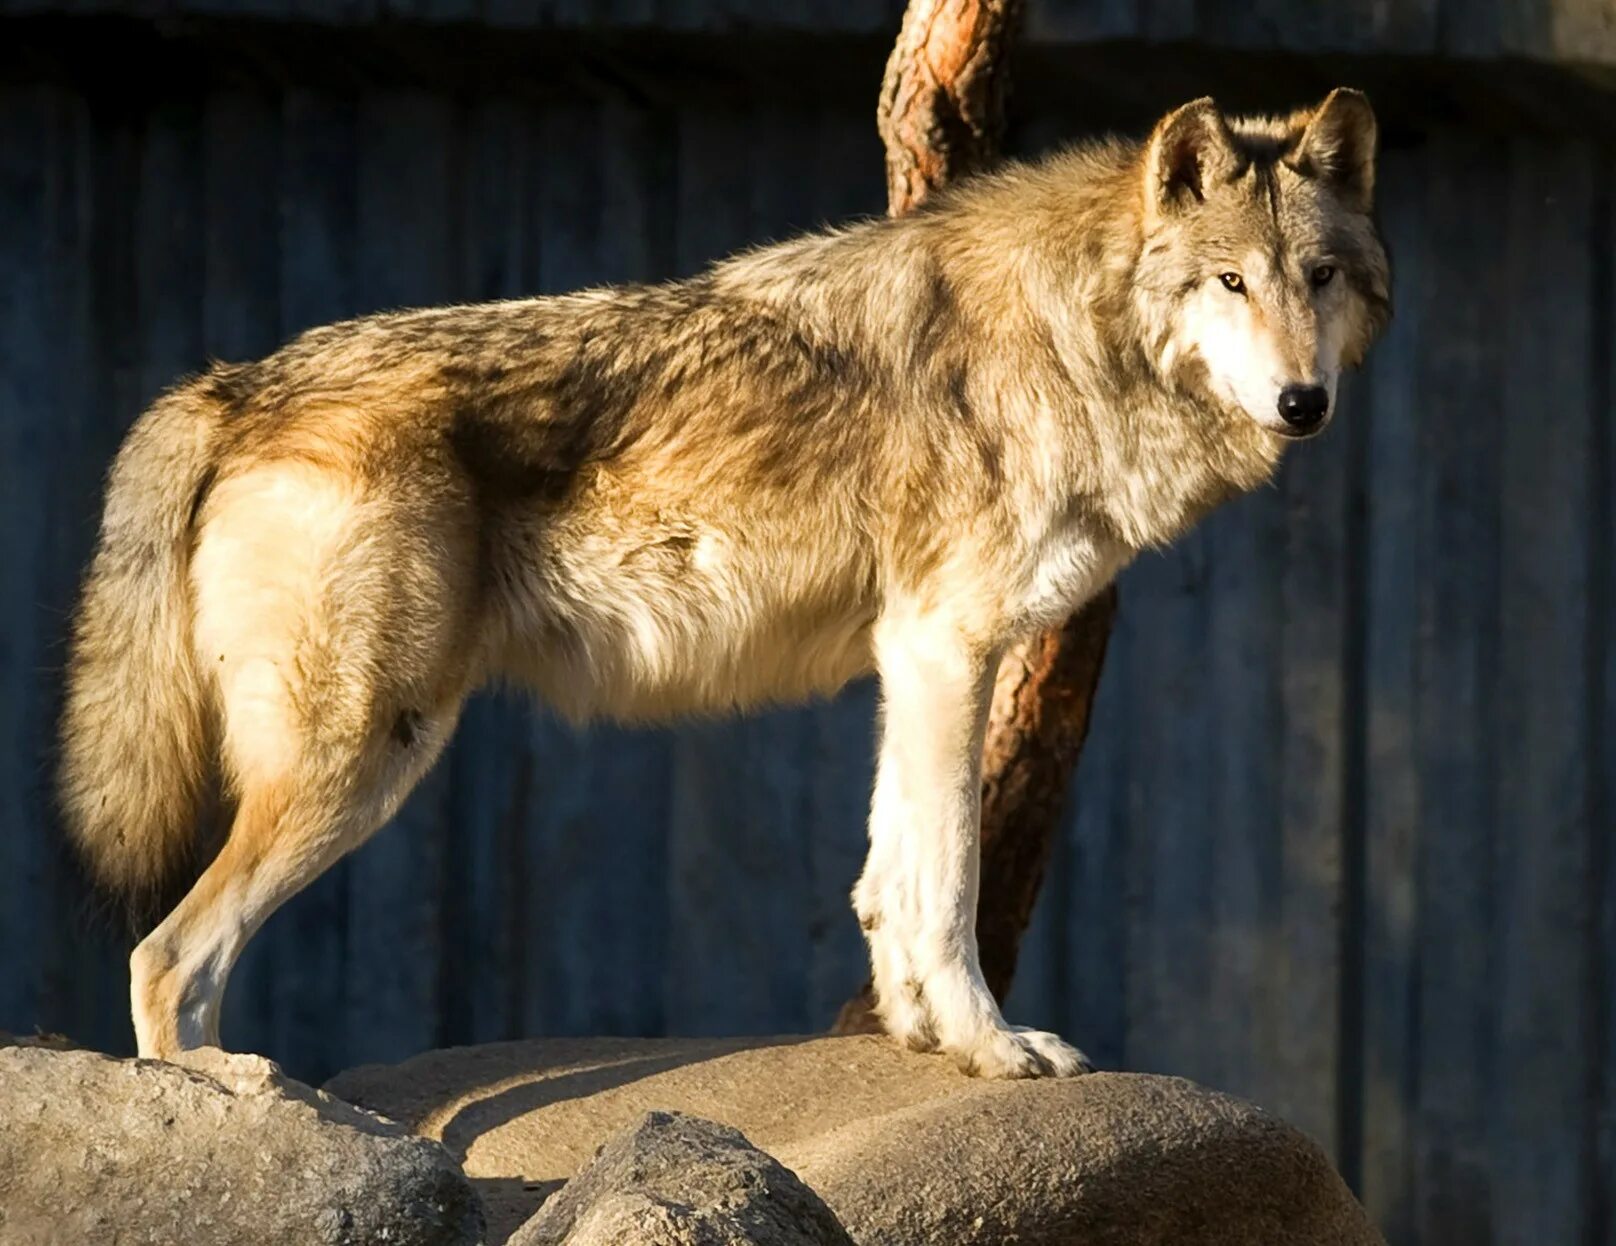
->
xmin=129 ymin=464 xmax=475 ymax=1057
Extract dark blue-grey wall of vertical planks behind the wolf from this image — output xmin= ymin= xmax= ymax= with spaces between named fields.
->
xmin=0 ymin=23 xmax=1616 ymax=1246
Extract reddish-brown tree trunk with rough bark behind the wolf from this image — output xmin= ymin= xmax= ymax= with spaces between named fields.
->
xmin=835 ymin=0 xmax=1117 ymax=1034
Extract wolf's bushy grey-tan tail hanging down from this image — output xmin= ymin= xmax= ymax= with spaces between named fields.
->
xmin=58 ymin=383 xmax=218 ymax=926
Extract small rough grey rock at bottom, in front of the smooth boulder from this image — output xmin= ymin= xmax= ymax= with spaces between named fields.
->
xmin=509 ymin=1112 xmax=853 ymax=1246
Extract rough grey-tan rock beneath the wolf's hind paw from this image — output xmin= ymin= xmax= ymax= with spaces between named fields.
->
xmin=0 ymin=1044 xmax=483 ymax=1246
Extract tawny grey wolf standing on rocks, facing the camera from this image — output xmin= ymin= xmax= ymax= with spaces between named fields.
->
xmin=60 ymin=89 xmax=1390 ymax=1078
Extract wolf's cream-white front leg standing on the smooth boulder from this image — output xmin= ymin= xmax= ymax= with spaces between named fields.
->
xmin=853 ymin=616 xmax=1088 ymax=1078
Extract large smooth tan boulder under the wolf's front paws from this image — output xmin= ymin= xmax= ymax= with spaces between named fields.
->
xmin=330 ymin=1038 xmax=1383 ymax=1246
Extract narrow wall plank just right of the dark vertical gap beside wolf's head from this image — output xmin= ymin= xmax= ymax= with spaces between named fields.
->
xmin=1348 ymin=143 xmax=1429 ymax=1243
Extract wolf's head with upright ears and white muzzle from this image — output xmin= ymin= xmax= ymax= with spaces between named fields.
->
xmin=1136 ymin=91 xmax=1391 ymax=436
